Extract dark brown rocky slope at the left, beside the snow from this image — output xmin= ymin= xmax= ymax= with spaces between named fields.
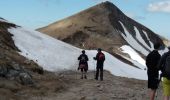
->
xmin=0 ymin=18 xmax=48 ymax=100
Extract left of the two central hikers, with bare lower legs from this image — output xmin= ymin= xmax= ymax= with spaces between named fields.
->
xmin=78 ymin=50 xmax=89 ymax=79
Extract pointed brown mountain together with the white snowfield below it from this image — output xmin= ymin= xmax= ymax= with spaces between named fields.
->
xmin=1 ymin=2 xmax=167 ymax=80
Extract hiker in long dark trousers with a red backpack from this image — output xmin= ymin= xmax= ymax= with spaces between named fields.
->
xmin=93 ymin=48 xmax=105 ymax=81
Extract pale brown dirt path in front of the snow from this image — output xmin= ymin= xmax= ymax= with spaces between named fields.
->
xmin=30 ymin=71 xmax=162 ymax=100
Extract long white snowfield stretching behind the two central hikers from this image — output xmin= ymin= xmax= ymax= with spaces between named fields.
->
xmin=8 ymin=27 xmax=147 ymax=80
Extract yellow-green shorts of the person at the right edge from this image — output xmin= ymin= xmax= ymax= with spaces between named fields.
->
xmin=162 ymin=77 xmax=170 ymax=96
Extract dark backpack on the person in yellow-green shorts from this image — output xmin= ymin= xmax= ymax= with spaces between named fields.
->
xmin=164 ymin=54 xmax=170 ymax=79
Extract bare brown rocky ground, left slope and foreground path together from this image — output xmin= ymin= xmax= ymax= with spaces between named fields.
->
xmin=0 ymin=17 xmax=165 ymax=100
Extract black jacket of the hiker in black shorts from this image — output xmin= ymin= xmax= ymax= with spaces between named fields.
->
xmin=146 ymin=50 xmax=161 ymax=74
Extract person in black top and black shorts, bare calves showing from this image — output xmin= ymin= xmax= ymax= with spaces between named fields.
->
xmin=146 ymin=44 xmax=161 ymax=100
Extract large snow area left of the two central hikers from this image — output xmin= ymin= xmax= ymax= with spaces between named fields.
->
xmin=9 ymin=27 xmax=80 ymax=71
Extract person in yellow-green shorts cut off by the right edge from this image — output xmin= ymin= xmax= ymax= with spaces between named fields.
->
xmin=159 ymin=46 xmax=170 ymax=100
